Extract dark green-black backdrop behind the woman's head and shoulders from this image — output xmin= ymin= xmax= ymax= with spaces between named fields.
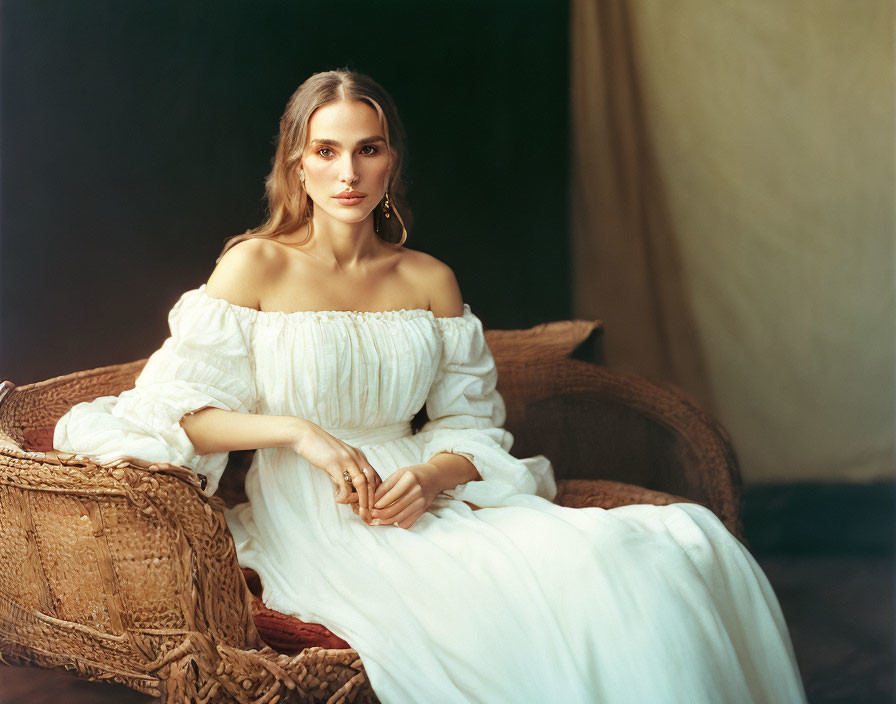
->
xmin=0 ymin=0 xmax=570 ymax=384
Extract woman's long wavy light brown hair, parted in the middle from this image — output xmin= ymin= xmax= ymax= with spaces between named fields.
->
xmin=216 ymin=69 xmax=413 ymax=262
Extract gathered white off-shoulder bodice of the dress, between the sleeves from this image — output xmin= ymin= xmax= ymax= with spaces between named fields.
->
xmin=197 ymin=285 xmax=448 ymax=430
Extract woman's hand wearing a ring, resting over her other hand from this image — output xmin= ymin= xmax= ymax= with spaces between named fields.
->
xmin=291 ymin=421 xmax=382 ymax=523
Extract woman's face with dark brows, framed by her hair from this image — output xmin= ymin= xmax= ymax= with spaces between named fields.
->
xmin=300 ymin=101 xmax=390 ymax=223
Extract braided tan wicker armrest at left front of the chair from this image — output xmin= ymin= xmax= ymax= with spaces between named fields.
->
xmin=0 ymin=447 xmax=372 ymax=704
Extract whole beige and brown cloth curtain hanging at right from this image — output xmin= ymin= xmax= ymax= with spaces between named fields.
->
xmin=570 ymin=0 xmax=896 ymax=481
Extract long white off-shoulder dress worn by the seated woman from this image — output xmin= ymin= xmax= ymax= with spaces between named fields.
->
xmin=53 ymin=285 xmax=805 ymax=704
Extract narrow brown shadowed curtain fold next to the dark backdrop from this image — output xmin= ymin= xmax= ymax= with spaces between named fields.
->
xmin=570 ymin=0 xmax=713 ymax=410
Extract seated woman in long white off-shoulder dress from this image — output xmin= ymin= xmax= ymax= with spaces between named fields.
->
xmin=54 ymin=71 xmax=805 ymax=704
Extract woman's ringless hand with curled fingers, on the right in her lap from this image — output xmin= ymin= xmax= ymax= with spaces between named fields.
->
xmin=371 ymin=462 xmax=443 ymax=528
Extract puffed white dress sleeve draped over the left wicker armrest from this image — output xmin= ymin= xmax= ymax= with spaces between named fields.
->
xmin=53 ymin=286 xmax=256 ymax=496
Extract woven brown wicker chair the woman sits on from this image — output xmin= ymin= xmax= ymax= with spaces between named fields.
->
xmin=0 ymin=321 xmax=741 ymax=704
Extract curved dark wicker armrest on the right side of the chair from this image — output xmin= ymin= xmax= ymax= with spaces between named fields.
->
xmin=499 ymin=359 xmax=742 ymax=538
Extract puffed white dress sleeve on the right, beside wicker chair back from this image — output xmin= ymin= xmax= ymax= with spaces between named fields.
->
xmin=419 ymin=303 xmax=557 ymax=508
